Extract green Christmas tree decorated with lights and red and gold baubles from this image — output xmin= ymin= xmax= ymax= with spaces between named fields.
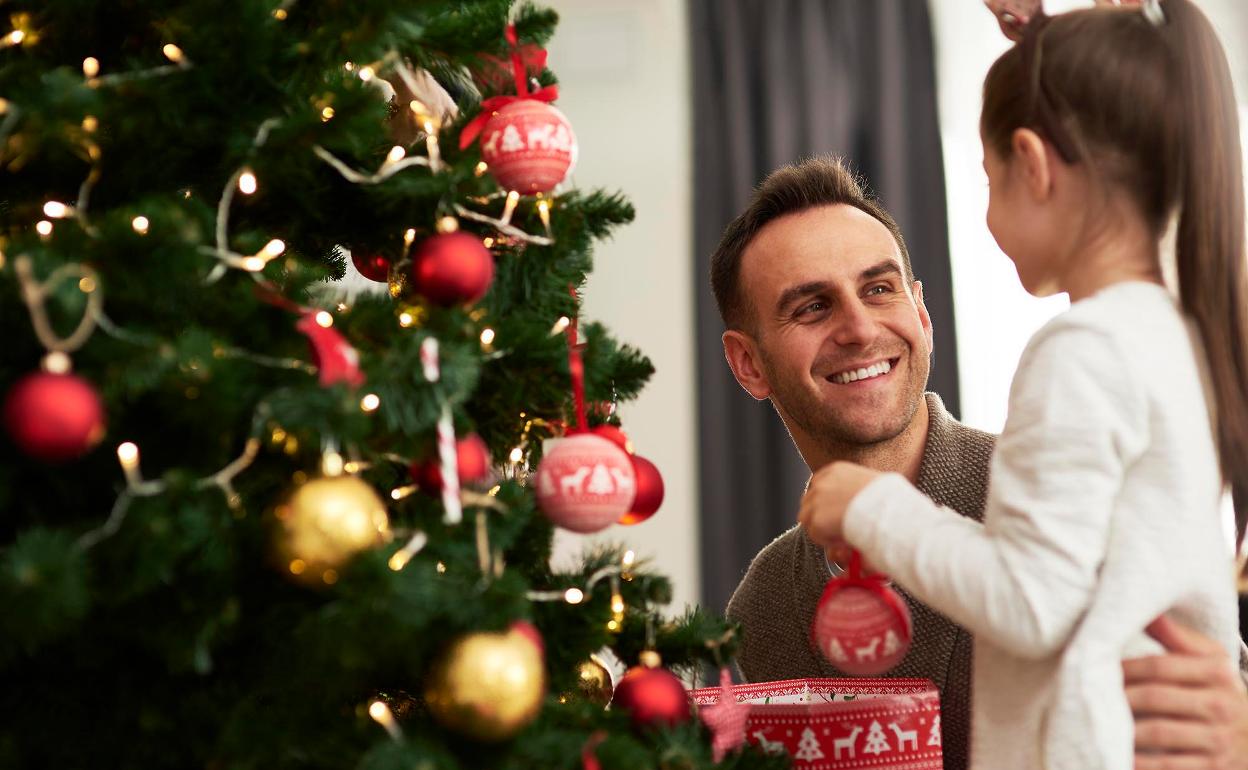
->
xmin=0 ymin=0 xmax=784 ymax=769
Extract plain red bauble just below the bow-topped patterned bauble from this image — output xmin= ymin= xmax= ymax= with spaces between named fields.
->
xmin=412 ymin=231 xmax=494 ymax=307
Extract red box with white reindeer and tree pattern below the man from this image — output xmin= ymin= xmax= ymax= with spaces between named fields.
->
xmin=691 ymin=679 xmax=942 ymax=770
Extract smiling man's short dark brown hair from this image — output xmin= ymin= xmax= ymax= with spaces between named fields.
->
xmin=710 ymin=155 xmax=915 ymax=329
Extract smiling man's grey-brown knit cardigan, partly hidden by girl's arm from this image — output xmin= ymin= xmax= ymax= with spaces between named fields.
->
xmin=728 ymin=393 xmax=996 ymax=770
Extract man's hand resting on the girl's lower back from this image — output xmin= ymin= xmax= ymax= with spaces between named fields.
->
xmin=1122 ymin=616 xmax=1248 ymax=770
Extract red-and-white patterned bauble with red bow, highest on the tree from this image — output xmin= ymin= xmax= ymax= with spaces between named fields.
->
xmin=480 ymin=99 xmax=577 ymax=193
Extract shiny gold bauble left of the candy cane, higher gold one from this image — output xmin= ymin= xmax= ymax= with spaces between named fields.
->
xmin=277 ymin=475 xmax=389 ymax=584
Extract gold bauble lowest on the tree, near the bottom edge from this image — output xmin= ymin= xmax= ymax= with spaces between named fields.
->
xmin=424 ymin=631 xmax=545 ymax=741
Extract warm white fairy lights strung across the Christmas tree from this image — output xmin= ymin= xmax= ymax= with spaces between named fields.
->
xmin=0 ymin=10 xmax=673 ymax=741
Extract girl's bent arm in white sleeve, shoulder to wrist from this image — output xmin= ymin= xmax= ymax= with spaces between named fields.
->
xmin=844 ymin=324 xmax=1148 ymax=658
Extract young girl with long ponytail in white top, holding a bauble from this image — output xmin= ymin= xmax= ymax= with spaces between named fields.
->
xmin=799 ymin=0 xmax=1248 ymax=770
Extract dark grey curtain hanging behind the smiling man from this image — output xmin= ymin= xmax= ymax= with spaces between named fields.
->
xmin=690 ymin=0 xmax=958 ymax=609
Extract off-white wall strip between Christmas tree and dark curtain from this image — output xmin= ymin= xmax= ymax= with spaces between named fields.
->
xmin=545 ymin=0 xmax=699 ymax=612
